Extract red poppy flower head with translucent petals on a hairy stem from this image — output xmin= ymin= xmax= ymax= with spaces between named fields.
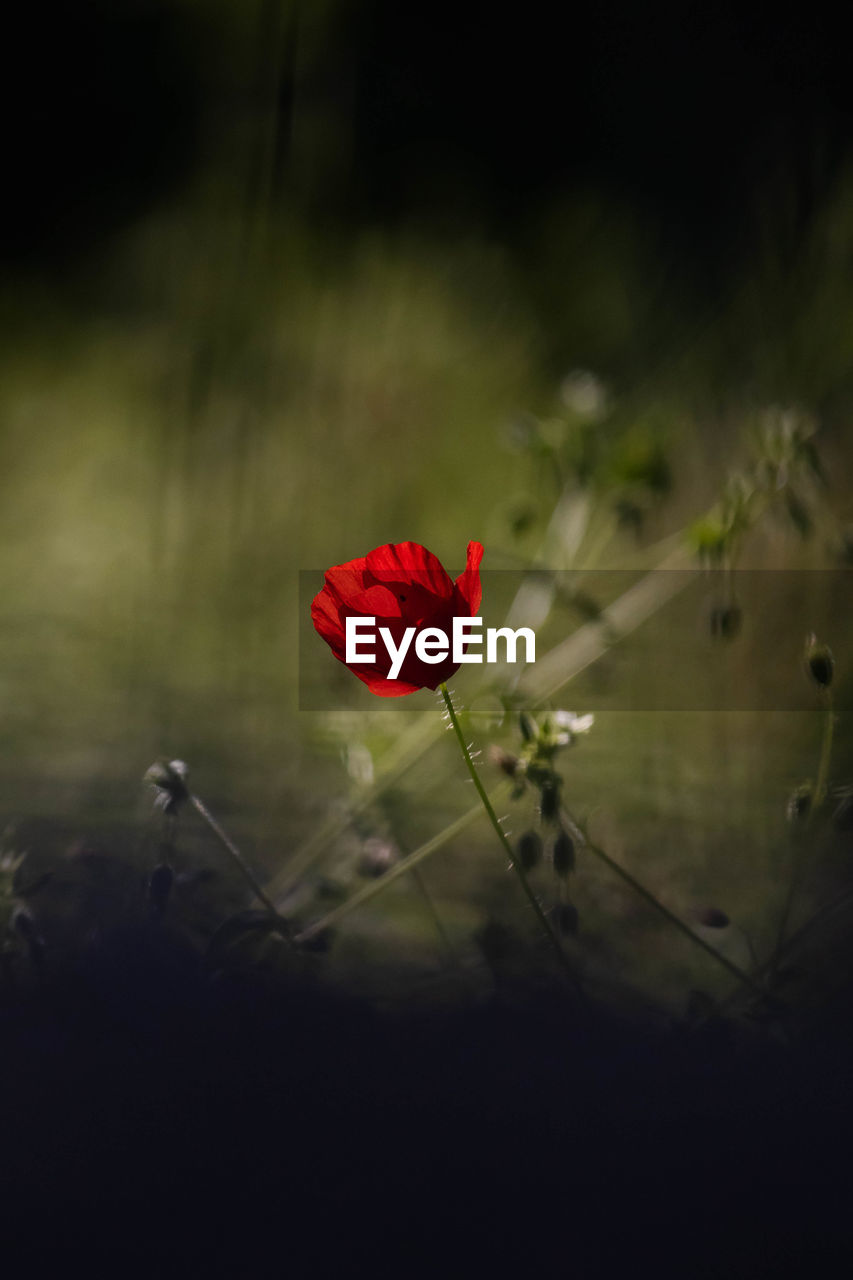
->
xmin=311 ymin=543 xmax=483 ymax=698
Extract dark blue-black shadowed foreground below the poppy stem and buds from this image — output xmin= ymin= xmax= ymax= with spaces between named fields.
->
xmin=0 ymin=923 xmax=853 ymax=1276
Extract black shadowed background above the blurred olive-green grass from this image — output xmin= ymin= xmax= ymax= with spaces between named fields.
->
xmin=3 ymin=0 xmax=853 ymax=282
